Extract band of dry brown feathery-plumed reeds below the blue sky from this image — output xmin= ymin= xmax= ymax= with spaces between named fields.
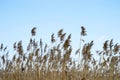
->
xmin=0 ymin=26 xmax=120 ymax=80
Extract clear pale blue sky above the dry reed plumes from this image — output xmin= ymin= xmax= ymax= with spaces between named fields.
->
xmin=0 ymin=0 xmax=120 ymax=59
